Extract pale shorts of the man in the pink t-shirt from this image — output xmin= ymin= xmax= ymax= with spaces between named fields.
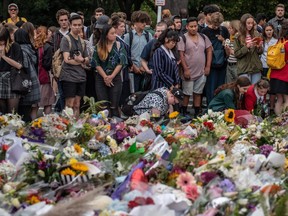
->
xmin=182 ymin=74 xmax=206 ymax=96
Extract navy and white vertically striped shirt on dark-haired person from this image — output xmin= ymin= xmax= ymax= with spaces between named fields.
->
xmin=151 ymin=46 xmax=180 ymax=89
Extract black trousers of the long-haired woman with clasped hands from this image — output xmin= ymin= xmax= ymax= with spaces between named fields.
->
xmin=95 ymin=73 xmax=122 ymax=117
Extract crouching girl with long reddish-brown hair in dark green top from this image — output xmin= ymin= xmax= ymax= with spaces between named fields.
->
xmin=208 ymin=77 xmax=251 ymax=111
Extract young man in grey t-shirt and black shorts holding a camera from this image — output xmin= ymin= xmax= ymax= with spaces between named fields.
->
xmin=59 ymin=13 xmax=89 ymax=118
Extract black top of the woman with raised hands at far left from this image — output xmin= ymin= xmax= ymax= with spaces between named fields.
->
xmin=0 ymin=42 xmax=23 ymax=72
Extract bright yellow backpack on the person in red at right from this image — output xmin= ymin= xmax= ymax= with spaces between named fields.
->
xmin=267 ymin=40 xmax=288 ymax=70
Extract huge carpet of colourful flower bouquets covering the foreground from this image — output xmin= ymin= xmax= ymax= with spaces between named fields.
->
xmin=0 ymin=108 xmax=288 ymax=216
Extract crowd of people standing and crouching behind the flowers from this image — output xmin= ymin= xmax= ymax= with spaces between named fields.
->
xmin=0 ymin=3 xmax=288 ymax=121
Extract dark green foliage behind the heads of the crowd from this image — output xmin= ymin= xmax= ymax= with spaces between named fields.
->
xmin=0 ymin=0 xmax=287 ymax=26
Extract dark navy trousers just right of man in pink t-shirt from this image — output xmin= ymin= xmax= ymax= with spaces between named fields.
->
xmin=205 ymin=65 xmax=226 ymax=105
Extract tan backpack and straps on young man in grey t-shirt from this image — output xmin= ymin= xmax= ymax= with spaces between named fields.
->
xmin=52 ymin=35 xmax=85 ymax=79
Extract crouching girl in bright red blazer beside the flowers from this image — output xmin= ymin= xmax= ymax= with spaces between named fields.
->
xmin=245 ymin=78 xmax=270 ymax=115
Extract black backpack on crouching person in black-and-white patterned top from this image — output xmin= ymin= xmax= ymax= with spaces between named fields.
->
xmin=121 ymin=91 xmax=164 ymax=116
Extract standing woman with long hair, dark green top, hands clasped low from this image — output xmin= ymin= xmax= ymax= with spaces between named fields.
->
xmin=91 ymin=25 xmax=127 ymax=117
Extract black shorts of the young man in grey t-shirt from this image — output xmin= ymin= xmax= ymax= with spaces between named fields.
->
xmin=60 ymin=81 xmax=86 ymax=98
